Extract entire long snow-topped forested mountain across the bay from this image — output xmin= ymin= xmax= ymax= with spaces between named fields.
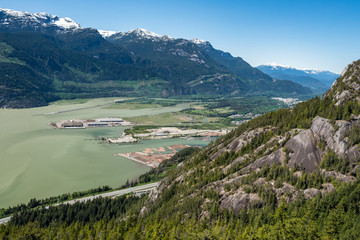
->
xmin=0 ymin=9 xmax=311 ymax=108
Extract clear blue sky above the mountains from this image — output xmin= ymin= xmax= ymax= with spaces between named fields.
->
xmin=0 ymin=0 xmax=360 ymax=73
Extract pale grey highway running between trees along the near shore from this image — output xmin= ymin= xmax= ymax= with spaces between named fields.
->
xmin=0 ymin=182 xmax=159 ymax=225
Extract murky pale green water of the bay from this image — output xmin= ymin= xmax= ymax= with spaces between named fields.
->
xmin=0 ymin=98 xmax=206 ymax=208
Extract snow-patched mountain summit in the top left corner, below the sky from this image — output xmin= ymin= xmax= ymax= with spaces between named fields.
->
xmin=0 ymin=8 xmax=81 ymax=30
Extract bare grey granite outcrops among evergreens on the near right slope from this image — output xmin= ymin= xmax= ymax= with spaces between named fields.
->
xmin=211 ymin=113 xmax=360 ymax=213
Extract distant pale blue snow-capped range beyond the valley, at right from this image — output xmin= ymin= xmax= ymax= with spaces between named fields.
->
xmin=256 ymin=64 xmax=340 ymax=93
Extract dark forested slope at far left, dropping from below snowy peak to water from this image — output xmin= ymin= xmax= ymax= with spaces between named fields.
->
xmin=0 ymin=32 xmax=143 ymax=107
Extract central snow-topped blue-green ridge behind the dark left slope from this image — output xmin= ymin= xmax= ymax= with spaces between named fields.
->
xmin=106 ymin=29 xmax=311 ymax=96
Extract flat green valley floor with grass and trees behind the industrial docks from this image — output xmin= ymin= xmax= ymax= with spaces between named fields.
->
xmin=119 ymin=96 xmax=300 ymax=133
